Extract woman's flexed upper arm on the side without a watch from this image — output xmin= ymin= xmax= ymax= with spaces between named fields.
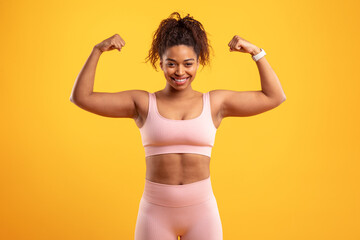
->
xmin=74 ymin=90 xmax=138 ymax=118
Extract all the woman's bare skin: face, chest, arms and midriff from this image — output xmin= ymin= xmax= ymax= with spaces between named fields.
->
xmin=70 ymin=34 xmax=286 ymax=185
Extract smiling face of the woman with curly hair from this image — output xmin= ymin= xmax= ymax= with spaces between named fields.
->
xmin=160 ymin=45 xmax=199 ymax=89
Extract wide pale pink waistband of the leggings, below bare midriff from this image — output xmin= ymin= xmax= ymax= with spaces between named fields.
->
xmin=142 ymin=176 xmax=214 ymax=207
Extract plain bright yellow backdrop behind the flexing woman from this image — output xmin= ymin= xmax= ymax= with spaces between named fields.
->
xmin=0 ymin=0 xmax=360 ymax=240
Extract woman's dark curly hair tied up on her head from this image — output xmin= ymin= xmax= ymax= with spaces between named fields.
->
xmin=145 ymin=12 xmax=213 ymax=71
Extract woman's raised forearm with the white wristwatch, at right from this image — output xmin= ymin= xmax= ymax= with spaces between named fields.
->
xmin=251 ymin=48 xmax=286 ymax=102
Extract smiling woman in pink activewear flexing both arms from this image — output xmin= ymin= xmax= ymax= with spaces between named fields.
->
xmin=70 ymin=12 xmax=285 ymax=240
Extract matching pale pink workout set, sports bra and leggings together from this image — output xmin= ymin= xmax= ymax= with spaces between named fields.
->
xmin=135 ymin=92 xmax=223 ymax=240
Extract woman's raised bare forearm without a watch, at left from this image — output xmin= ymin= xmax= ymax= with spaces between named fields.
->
xmin=70 ymin=47 xmax=101 ymax=101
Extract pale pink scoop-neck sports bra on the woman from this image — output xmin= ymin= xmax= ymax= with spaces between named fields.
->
xmin=139 ymin=92 xmax=217 ymax=157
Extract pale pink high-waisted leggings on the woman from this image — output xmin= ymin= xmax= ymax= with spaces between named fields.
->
xmin=135 ymin=177 xmax=223 ymax=240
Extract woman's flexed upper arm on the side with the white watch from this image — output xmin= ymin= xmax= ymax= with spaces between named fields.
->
xmin=221 ymin=90 xmax=280 ymax=117
